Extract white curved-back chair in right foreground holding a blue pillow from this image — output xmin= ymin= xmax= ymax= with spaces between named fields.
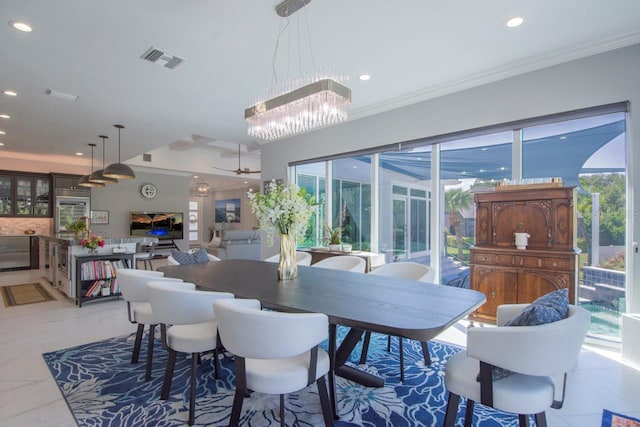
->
xmin=444 ymin=304 xmax=590 ymax=427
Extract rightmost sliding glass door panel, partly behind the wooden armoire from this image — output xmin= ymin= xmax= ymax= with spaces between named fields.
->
xmin=522 ymin=113 xmax=628 ymax=342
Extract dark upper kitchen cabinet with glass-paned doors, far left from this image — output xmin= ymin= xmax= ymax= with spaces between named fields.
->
xmin=0 ymin=171 xmax=52 ymax=217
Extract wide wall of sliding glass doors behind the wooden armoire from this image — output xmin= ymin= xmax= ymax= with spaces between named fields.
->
xmin=296 ymin=104 xmax=631 ymax=348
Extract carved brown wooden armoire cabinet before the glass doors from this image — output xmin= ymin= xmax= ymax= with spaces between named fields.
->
xmin=470 ymin=186 xmax=579 ymax=322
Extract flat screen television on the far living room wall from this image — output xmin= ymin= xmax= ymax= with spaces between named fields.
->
xmin=129 ymin=212 xmax=184 ymax=240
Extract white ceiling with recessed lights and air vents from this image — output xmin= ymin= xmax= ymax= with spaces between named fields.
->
xmin=0 ymin=0 xmax=640 ymax=186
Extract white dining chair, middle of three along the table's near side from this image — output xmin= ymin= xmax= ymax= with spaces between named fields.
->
xmin=147 ymin=281 xmax=234 ymax=425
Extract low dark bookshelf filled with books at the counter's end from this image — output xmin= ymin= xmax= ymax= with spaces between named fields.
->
xmin=75 ymin=253 xmax=134 ymax=307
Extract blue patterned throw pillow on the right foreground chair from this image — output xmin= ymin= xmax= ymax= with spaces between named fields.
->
xmin=505 ymin=288 xmax=569 ymax=326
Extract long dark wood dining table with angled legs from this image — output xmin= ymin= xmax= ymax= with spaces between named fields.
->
xmin=158 ymin=259 xmax=485 ymax=418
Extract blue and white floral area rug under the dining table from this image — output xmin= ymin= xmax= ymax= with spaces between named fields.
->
xmin=43 ymin=334 xmax=518 ymax=427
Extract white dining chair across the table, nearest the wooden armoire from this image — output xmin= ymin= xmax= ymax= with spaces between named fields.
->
xmin=360 ymin=261 xmax=435 ymax=381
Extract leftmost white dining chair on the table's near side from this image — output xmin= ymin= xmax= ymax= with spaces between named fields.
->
xmin=117 ymin=268 xmax=189 ymax=381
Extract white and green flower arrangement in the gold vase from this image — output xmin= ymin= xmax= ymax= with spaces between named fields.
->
xmin=247 ymin=180 xmax=316 ymax=246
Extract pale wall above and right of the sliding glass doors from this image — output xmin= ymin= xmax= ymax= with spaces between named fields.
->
xmin=261 ymin=45 xmax=640 ymax=312
